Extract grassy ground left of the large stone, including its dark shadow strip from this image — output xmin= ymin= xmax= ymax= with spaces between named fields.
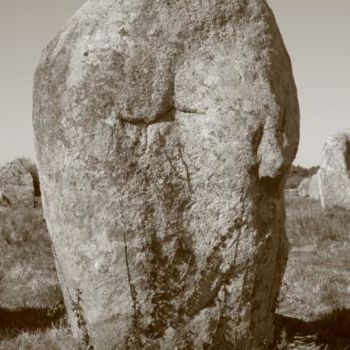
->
xmin=0 ymin=208 xmax=69 ymax=350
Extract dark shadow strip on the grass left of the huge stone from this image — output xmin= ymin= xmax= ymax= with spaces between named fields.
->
xmin=0 ymin=307 xmax=66 ymax=339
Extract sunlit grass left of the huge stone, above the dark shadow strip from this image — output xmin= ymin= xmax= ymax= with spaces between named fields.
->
xmin=0 ymin=208 xmax=62 ymax=311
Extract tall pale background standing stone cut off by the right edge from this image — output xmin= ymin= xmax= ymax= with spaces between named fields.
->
xmin=318 ymin=130 xmax=350 ymax=209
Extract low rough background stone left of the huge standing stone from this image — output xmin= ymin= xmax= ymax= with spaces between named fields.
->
xmin=0 ymin=158 xmax=35 ymax=208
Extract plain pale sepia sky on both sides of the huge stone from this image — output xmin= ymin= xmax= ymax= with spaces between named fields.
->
xmin=0 ymin=0 xmax=350 ymax=166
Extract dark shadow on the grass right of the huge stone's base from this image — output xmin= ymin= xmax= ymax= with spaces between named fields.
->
xmin=276 ymin=309 xmax=350 ymax=350
